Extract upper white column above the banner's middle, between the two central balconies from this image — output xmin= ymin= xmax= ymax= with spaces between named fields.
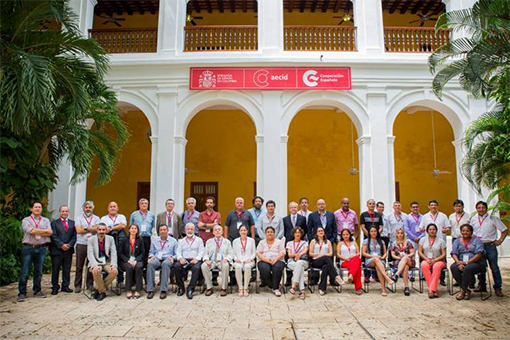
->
xmin=258 ymin=0 xmax=283 ymax=55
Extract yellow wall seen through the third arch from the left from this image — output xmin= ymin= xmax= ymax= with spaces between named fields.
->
xmin=288 ymin=109 xmax=360 ymax=214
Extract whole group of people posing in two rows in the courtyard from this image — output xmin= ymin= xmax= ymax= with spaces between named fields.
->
xmin=18 ymin=196 xmax=508 ymax=302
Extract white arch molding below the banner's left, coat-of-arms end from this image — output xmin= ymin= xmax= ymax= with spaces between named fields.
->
xmin=175 ymin=91 xmax=264 ymax=136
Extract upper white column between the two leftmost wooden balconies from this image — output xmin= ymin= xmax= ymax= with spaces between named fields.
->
xmin=158 ymin=0 xmax=187 ymax=56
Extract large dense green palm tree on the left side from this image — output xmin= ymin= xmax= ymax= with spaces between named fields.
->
xmin=0 ymin=0 xmax=129 ymax=213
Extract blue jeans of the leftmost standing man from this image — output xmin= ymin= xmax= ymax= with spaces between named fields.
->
xmin=18 ymin=246 xmax=46 ymax=296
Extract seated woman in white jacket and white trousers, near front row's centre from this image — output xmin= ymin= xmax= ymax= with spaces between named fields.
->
xmin=232 ymin=225 xmax=256 ymax=297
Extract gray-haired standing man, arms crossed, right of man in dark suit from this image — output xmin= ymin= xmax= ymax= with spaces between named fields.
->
xmin=74 ymin=201 xmax=101 ymax=293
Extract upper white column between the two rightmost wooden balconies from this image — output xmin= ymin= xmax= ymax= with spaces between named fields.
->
xmin=352 ymin=0 xmax=384 ymax=54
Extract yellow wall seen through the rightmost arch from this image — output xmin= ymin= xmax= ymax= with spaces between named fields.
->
xmin=393 ymin=111 xmax=458 ymax=213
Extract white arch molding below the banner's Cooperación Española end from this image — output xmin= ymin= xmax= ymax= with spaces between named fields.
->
xmin=281 ymin=91 xmax=369 ymax=136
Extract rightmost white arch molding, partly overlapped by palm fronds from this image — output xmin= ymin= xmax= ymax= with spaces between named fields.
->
xmin=386 ymin=90 xmax=469 ymax=140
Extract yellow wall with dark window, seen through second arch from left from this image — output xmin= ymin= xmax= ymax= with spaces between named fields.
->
xmin=185 ymin=110 xmax=256 ymax=222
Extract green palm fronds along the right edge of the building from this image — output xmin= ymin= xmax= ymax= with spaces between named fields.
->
xmin=429 ymin=0 xmax=510 ymax=220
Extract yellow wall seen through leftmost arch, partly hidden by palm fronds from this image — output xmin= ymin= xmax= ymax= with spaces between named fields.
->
xmin=87 ymin=111 xmax=151 ymax=218
